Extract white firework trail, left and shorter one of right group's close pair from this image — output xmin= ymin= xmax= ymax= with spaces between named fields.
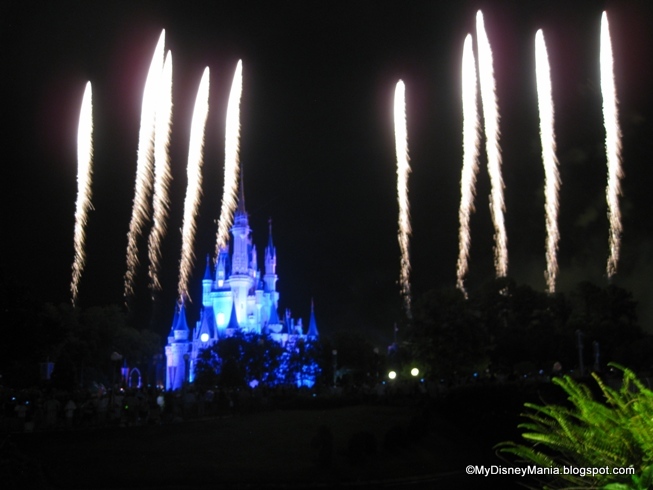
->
xmin=456 ymin=34 xmax=480 ymax=296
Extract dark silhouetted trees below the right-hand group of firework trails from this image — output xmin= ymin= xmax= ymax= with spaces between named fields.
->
xmin=408 ymin=278 xmax=653 ymax=378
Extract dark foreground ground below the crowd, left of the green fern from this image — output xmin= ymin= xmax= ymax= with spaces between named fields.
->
xmin=0 ymin=385 xmax=555 ymax=490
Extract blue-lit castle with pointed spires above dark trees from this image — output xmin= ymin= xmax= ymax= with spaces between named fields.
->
xmin=165 ymin=174 xmax=318 ymax=390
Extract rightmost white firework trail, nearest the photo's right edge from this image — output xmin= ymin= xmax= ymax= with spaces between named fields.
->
xmin=601 ymin=12 xmax=623 ymax=278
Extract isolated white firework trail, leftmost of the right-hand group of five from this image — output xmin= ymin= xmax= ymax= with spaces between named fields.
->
xmin=394 ymin=80 xmax=411 ymax=318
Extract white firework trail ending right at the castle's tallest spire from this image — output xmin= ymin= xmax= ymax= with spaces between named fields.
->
xmin=215 ymin=60 xmax=243 ymax=256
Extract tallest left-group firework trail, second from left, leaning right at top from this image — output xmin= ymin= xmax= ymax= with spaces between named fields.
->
xmin=124 ymin=30 xmax=165 ymax=298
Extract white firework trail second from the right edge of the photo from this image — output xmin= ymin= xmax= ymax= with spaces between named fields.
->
xmin=535 ymin=29 xmax=560 ymax=293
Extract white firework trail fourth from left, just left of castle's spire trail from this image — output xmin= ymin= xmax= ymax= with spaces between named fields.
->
xmin=177 ymin=67 xmax=209 ymax=301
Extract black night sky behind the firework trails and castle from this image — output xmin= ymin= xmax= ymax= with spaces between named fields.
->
xmin=0 ymin=0 xmax=653 ymax=341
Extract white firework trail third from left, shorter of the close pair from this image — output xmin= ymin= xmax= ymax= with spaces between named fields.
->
xmin=148 ymin=51 xmax=172 ymax=291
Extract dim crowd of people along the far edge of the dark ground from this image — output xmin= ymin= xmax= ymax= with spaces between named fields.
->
xmin=0 ymin=376 xmax=438 ymax=432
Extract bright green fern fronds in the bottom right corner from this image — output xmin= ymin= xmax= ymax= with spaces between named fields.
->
xmin=497 ymin=364 xmax=653 ymax=490
